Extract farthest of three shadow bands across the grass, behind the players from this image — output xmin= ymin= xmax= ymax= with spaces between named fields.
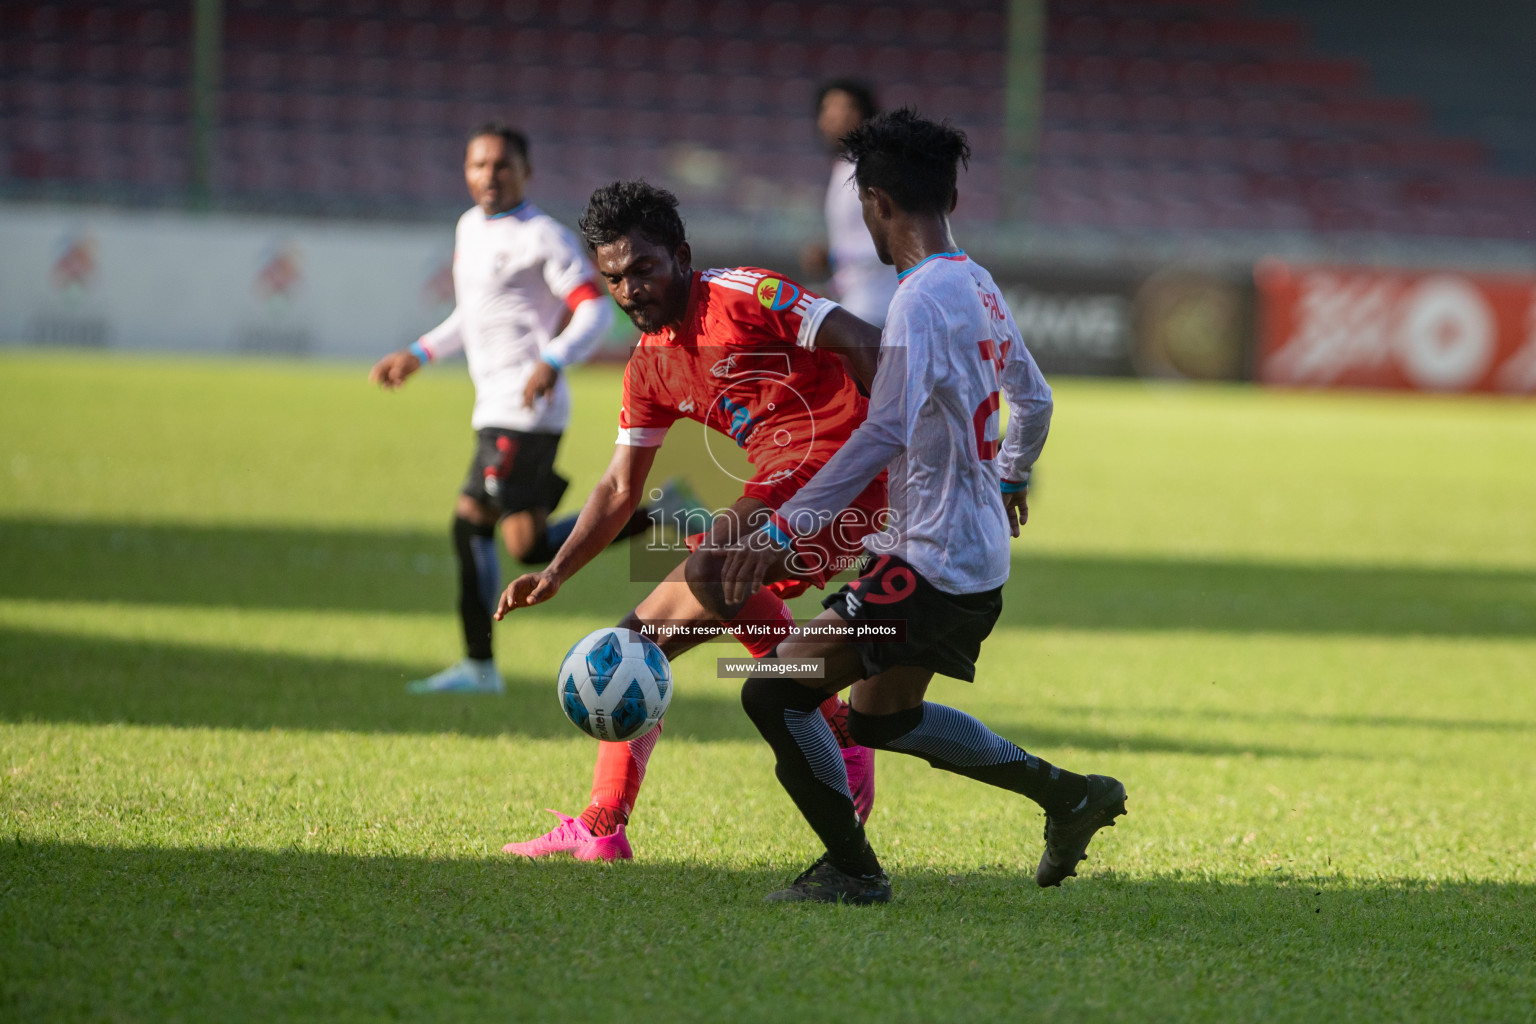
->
xmin=9 ymin=519 xmax=1536 ymax=637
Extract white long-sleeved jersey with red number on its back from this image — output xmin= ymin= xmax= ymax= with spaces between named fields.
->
xmin=774 ymin=252 xmax=1052 ymax=594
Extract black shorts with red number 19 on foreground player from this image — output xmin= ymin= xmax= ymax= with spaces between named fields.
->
xmin=822 ymin=554 xmax=1003 ymax=683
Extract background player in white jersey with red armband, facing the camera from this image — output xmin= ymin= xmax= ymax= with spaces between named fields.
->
xmin=369 ymin=124 xmax=632 ymax=692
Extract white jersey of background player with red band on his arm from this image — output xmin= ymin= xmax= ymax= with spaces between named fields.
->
xmin=419 ymin=203 xmax=613 ymax=433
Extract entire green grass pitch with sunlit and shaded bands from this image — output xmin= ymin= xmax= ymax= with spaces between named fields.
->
xmin=0 ymin=350 xmax=1536 ymax=1024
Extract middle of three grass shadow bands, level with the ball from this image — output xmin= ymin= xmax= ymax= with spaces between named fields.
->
xmin=0 ymin=628 xmax=1350 ymax=757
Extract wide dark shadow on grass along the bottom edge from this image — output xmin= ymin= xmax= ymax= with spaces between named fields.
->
xmin=0 ymin=837 xmax=1536 ymax=1021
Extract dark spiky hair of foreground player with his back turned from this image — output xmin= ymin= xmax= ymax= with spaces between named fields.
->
xmin=843 ymin=107 xmax=971 ymax=213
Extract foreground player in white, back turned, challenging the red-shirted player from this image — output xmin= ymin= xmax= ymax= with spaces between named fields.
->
xmin=700 ymin=111 xmax=1126 ymax=903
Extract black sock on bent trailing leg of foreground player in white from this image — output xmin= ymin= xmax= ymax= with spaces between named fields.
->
xmin=848 ymin=702 xmax=1087 ymax=814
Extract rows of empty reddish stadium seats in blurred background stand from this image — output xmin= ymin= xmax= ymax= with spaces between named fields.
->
xmin=0 ymin=0 xmax=1536 ymax=236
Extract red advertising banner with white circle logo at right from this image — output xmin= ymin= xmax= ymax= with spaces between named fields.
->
xmin=1253 ymin=261 xmax=1536 ymax=395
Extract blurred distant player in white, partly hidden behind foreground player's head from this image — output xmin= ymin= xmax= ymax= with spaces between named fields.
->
xmin=806 ymin=78 xmax=895 ymax=324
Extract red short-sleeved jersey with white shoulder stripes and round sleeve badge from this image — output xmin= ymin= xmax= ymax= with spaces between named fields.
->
xmin=619 ymin=267 xmax=868 ymax=508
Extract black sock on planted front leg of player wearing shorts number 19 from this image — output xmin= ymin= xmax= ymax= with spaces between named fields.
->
xmin=742 ymin=677 xmax=880 ymax=877
